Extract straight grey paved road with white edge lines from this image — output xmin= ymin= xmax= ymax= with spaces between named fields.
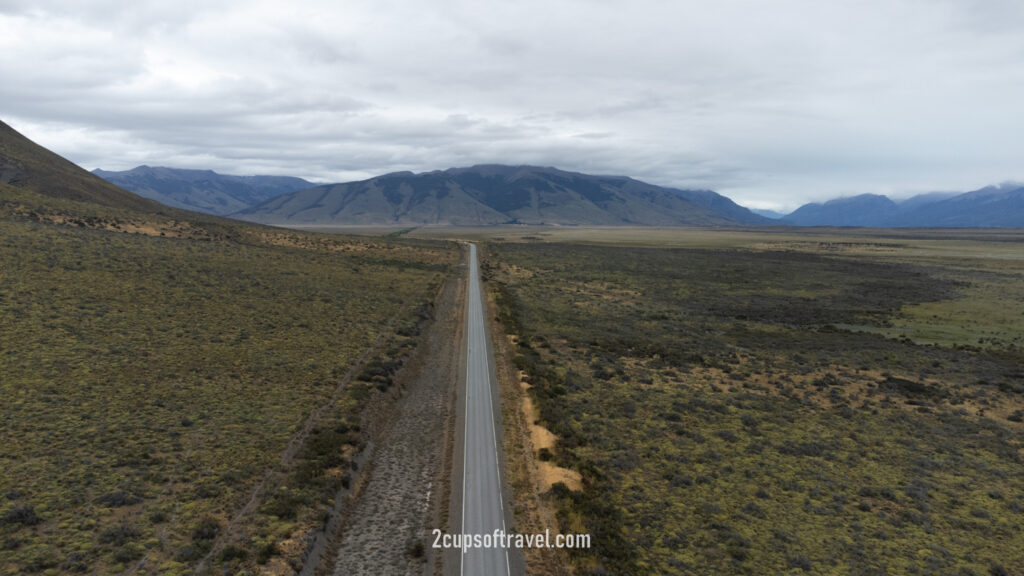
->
xmin=460 ymin=244 xmax=511 ymax=576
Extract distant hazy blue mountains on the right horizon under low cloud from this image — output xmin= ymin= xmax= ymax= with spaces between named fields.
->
xmin=777 ymin=182 xmax=1024 ymax=228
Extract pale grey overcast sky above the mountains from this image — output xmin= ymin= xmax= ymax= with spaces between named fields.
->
xmin=0 ymin=0 xmax=1024 ymax=209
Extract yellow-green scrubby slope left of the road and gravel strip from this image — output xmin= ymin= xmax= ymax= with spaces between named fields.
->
xmin=0 ymin=184 xmax=457 ymax=574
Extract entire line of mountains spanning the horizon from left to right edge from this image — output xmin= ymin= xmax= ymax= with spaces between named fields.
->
xmin=0 ymin=111 xmax=1024 ymax=228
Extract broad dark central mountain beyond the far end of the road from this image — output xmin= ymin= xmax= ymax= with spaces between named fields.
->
xmin=234 ymin=165 xmax=769 ymax=225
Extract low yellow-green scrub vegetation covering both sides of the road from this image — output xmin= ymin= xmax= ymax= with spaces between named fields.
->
xmin=8 ymin=120 xmax=1024 ymax=575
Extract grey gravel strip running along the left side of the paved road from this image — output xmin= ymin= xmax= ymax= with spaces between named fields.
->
xmin=331 ymin=270 xmax=465 ymax=576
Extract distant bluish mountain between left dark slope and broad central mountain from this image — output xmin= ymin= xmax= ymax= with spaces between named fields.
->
xmin=92 ymin=166 xmax=314 ymax=215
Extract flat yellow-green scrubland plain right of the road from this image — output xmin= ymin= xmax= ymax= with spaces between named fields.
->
xmin=487 ymin=237 xmax=1024 ymax=574
